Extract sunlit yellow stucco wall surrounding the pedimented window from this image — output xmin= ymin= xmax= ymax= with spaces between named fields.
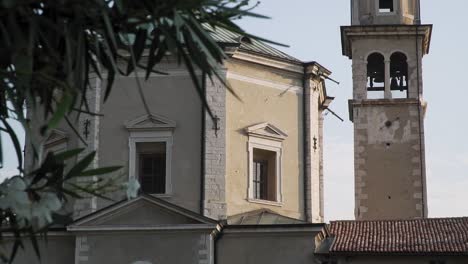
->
xmin=226 ymin=61 xmax=304 ymax=218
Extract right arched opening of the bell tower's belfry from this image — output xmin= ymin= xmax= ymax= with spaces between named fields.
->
xmin=390 ymin=52 xmax=408 ymax=98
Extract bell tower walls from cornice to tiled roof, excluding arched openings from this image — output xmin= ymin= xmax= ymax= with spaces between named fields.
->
xmin=348 ymin=28 xmax=427 ymax=220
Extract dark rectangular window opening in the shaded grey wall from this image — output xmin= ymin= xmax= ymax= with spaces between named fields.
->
xmin=136 ymin=142 xmax=166 ymax=194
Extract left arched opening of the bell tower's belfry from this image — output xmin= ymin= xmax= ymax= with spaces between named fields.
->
xmin=367 ymin=52 xmax=385 ymax=99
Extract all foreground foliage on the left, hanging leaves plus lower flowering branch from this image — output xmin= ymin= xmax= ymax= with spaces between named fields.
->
xmin=0 ymin=0 xmax=270 ymax=261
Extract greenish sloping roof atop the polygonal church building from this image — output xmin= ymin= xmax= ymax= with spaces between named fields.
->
xmin=204 ymin=24 xmax=302 ymax=64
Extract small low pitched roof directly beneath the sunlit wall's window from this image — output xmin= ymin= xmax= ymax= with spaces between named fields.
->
xmin=227 ymin=209 xmax=305 ymax=225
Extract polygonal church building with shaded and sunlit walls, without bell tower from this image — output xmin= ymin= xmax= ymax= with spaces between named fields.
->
xmin=18 ymin=17 xmax=333 ymax=264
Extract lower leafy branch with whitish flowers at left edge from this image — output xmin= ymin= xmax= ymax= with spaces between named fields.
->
xmin=0 ymin=149 xmax=132 ymax=262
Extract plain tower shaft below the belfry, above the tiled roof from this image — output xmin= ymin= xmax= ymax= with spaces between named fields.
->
xmin=353 ymin=99 xmax=427 ymax=220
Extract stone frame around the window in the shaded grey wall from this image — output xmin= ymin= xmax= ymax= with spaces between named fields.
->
xmin=128 ymin=131 xmax=173 ymax=197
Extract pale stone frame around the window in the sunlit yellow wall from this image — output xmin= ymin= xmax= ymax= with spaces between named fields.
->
xmin=247 ymin=135 xmax=283 ymax=206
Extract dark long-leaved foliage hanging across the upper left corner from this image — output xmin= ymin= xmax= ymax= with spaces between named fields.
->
xmin=0 ymin=0 xmax=268 ymax=133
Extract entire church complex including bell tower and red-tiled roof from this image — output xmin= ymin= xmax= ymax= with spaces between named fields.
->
xmin=14 ymin=0 xmax=468 ymax=264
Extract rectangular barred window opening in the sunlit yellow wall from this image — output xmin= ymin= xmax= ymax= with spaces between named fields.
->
xmin=253 ymin=148 xmax=277 ymax=201
